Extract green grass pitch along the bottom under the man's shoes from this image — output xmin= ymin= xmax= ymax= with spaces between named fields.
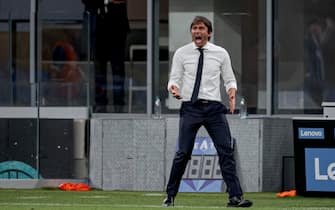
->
xmin=0 ymin=189 xmax=335 ymax=210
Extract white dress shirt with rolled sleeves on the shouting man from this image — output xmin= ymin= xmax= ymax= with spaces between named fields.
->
xmin=168 ymin=42 xmax=237 ymax=101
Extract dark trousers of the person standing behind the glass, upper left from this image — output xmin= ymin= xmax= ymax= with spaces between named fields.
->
xmin=95 ymin=16 xmax=128 ymax=106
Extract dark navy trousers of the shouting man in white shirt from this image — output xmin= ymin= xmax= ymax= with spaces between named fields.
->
xmin=166 ymin=100 xmax=243 ymax=197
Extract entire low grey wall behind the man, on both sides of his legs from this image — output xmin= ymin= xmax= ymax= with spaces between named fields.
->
xmin=89 ymin=116 xmax=293 ymax=192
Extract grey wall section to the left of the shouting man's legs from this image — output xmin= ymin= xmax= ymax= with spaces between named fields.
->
xmin=90 ymin=119 xmax=165 ymax=190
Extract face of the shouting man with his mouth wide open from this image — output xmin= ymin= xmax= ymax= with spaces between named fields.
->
xmin=191 ymin=22 xmax=211 ymax=47
